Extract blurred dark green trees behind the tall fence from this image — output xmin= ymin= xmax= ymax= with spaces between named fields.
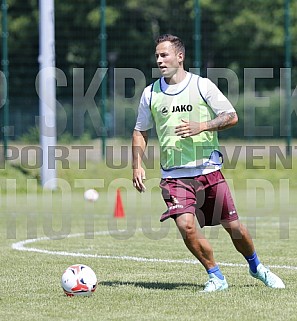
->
xmin=0 ymin=0 xmax=297 ymax=142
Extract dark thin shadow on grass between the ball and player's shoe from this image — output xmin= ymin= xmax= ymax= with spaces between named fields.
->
xmin=99 ymin=281 xmax=203 ymax=290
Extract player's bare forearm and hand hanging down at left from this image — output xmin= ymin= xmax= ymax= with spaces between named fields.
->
xmin=132 ymin=129 xmax=148 ymax=192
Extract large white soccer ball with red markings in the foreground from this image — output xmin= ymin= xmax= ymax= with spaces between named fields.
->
xmin=61 ymin=264 xmax=98 ymax=296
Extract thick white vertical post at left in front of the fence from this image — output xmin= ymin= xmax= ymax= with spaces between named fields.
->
xmin=37 ymin=0 xmax=57 ymax=190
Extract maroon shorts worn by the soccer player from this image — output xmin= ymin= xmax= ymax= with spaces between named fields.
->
xmin=160 ymin=171 xmax=238 ymax=227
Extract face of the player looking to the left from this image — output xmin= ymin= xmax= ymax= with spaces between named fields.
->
xmin=155 ymin=41 xmax=183 ymax=78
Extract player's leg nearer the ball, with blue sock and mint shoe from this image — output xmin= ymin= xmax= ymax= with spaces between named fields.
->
xmin=175 ymin=213 xmax=228 ymax=292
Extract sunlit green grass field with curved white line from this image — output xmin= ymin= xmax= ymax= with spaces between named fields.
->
xmin=0 ymin=144 xmax=297 ymax=321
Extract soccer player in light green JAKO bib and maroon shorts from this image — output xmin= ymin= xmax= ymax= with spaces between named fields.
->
xmin=132 ymin=34 xmax=285 ymax=292
